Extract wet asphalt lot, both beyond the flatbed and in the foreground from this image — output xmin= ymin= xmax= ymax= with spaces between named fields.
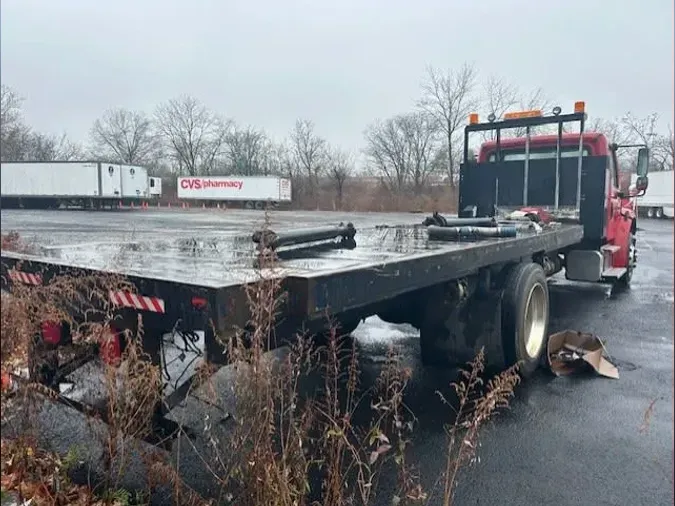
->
xmin=1 ymin=211 xmax=674 ymax=505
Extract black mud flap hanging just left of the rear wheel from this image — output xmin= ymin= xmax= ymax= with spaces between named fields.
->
xmin=420 ymin=291 xmax=506 ymax=369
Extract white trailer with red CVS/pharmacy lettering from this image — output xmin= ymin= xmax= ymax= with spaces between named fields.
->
xmin=177 ymin=176 xmax=291 ymax=209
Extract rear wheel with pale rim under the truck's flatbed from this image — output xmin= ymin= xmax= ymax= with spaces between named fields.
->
xmin=502 ymin=263 xmax=549 ymax=377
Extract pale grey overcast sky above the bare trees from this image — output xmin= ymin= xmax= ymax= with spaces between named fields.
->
xmin=0 ymin=0 xmax=674 ymax=154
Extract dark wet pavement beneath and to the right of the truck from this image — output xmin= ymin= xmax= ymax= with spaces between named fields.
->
xmin=356 ymin=220 xmax=674 ymax=506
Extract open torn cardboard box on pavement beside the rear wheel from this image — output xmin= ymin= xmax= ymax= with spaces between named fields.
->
xmin=547 ymin=330 xmax=619 ymax=379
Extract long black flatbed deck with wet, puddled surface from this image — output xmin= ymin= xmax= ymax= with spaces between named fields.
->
xmin=2 ymin=208 xmax=583 ymax=331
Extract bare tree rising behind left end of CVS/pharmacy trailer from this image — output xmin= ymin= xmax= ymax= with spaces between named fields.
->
xmin=156 ymin=95 xmax=229 ymax=176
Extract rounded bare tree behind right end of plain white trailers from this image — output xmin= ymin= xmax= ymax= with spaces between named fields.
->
xmin=90 ymin=108 xmax=159 ymax=164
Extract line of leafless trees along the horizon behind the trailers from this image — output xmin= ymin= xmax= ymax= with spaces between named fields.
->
xmin=0 ymin=60 xmax=674 ymax=199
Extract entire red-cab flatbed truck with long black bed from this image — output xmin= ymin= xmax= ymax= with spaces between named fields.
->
xmin=0 ymin=103 xmax=649 ymax=442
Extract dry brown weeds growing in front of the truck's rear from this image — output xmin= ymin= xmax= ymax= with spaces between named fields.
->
xmin=0 ymin=230 xmax=518 ymax=506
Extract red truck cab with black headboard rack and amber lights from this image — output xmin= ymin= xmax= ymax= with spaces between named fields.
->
xmin=459 ymin=102 xmax=649 ymax=281
